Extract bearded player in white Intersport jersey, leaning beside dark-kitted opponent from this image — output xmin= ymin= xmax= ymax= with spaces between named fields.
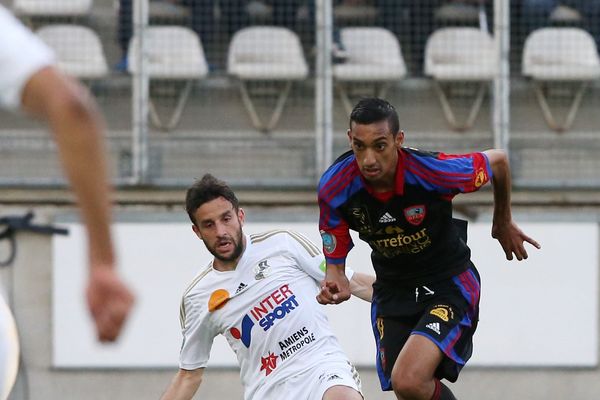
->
xmin=162 ymin=174 xmax=374 ymax=400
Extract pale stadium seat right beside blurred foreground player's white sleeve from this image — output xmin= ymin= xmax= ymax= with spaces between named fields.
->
xmin=36 ymin=24 xmax=108 ymax=79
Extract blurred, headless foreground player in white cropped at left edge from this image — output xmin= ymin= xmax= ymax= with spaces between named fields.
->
xmin=0 ymin=5 xmax=133 ymax=400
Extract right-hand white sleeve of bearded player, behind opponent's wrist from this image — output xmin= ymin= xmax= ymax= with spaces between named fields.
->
xmin=288 ymin=231 xmax=354 ymax=283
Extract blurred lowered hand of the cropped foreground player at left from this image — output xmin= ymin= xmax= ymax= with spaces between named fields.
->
xmin=87 ymin=267 xmax=134 ymax=342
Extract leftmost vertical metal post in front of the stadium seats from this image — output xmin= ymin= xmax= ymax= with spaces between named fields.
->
xmin=129 ymin=0 xmax=149 ymax=185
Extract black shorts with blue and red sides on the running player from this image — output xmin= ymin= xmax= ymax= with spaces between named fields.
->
xmin=371 ymin=265 xmax=480 ymax=390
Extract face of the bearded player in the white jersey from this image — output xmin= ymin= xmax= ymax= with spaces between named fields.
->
xmin=192 ymin=197 xmax=245 ymax=265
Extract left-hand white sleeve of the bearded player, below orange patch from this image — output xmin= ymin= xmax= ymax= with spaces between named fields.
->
xmin=179 ymin=297 xmax=218 ymax=370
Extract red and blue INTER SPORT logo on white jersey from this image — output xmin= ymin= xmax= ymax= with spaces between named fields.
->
xmin=229 ymin=284 xmax=300 ymax=347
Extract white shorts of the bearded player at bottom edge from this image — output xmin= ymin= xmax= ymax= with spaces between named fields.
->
xmin=254 ymin=361 xmax=364 ymax=400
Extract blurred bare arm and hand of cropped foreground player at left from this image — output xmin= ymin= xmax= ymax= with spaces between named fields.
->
xmin=21 ymin=67 xmax=133 ymax=341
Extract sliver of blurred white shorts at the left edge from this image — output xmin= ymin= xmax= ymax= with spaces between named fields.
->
xmin=0 ymin=295 xmax=19 ymax=400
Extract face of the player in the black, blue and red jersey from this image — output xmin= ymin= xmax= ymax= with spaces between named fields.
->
xmin=348 ymin=120 xmax=404 ymax=190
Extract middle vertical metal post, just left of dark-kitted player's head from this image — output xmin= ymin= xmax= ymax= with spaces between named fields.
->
xmin=315 ymin=0 xmax=333 ymax=179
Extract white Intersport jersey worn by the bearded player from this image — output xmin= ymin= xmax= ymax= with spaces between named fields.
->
xmin=180 ymin=230 xmax=352 ymax=400
